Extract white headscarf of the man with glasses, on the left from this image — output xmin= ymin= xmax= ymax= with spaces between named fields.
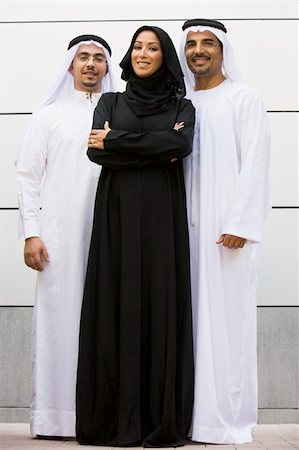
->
xmin=34 ymin=40 xmax=117 ymax=112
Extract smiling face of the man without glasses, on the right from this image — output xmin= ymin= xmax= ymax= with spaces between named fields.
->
xmin=185 ymin=31 xmax=223 ymax=78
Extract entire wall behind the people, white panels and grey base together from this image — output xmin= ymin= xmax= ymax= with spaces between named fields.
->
xmin=0 ymin=0 xmax=299 ymax=423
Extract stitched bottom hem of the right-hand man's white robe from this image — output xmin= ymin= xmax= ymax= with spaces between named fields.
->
xmin=191 ymin=425 xmax=254 ymax=444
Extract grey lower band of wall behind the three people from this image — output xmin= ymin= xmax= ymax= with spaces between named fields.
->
xmin=0 ymin=306 xmax=299 ymax=423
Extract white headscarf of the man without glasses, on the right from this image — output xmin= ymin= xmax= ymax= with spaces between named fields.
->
xmin=179 ymin=25 xmax=243 ymax=89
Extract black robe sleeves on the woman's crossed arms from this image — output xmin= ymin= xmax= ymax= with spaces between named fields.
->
xmin=87 ymin=96 xmax=195 ymax=168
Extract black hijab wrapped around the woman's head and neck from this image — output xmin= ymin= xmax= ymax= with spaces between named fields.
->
xmin=120 ymin=25 xmax=186 ymax=117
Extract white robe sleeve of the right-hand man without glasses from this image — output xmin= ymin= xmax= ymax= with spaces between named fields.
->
xmin=222 ymin=91 xmax=271 ymax=242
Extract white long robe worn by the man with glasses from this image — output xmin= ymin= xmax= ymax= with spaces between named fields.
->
xmin=17 ymin=88 xmax=101 ymax=436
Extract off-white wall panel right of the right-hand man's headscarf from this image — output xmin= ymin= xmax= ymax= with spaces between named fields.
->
xmin=224 ymin=20 xmax=298 ymax=110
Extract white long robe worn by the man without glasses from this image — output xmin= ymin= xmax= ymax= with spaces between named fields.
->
xmin=185 ymin=80 xmax=270 ymax=444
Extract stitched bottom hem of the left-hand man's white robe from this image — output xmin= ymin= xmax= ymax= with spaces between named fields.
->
xmin=30 ymin=410 xmax=76 ymax=437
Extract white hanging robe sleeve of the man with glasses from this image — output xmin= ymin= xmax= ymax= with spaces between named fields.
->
xmin=16 ymin=111 xmax=48 ymax=239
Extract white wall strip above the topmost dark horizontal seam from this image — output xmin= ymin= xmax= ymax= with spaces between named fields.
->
xmin=0 ymin=0 xmax=298 ymax=21
